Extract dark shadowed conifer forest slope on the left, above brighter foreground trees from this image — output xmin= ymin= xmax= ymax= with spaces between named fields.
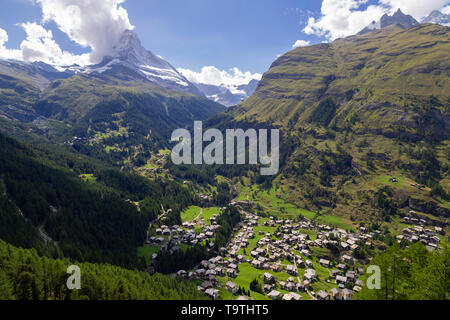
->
xmin=0 ymin=135 xmax=193 ymax=267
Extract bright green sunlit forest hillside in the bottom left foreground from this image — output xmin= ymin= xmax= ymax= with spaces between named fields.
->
xmin=0 ymin=240 xmax=205 ymax=300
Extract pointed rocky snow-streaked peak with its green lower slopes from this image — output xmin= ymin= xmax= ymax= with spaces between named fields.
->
xmin=0 ymin=31 xmax=224 ymax=166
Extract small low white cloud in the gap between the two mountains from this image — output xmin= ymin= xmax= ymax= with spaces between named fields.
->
xmin=178 ymin=66 xmax=262 ymax=89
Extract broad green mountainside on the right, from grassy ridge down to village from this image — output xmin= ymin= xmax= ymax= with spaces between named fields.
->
xmin=224 ymin=24 xmax=450 ymax=222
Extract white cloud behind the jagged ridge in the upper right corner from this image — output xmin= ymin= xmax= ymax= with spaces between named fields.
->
xmin=303 ymin=0 xmax=448 ymax=40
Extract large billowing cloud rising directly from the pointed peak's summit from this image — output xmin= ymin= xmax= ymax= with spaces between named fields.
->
xmin=36 ymin=0 xmax=134 ymax=63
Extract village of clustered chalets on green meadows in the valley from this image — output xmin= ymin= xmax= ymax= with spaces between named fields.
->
xmin=141 ymin=196 xmax=443 ymax=300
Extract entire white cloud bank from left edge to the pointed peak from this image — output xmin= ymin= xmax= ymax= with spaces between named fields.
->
xmin=0 ymin=0 xmax=134 ymax=66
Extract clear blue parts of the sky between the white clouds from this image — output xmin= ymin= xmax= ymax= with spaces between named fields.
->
xmin=0 ymin=0 xmax=321 ymax=73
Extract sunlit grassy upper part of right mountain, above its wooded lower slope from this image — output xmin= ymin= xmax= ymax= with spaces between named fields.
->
xmin=233 ymin=24 xmax=450 ymax=140
